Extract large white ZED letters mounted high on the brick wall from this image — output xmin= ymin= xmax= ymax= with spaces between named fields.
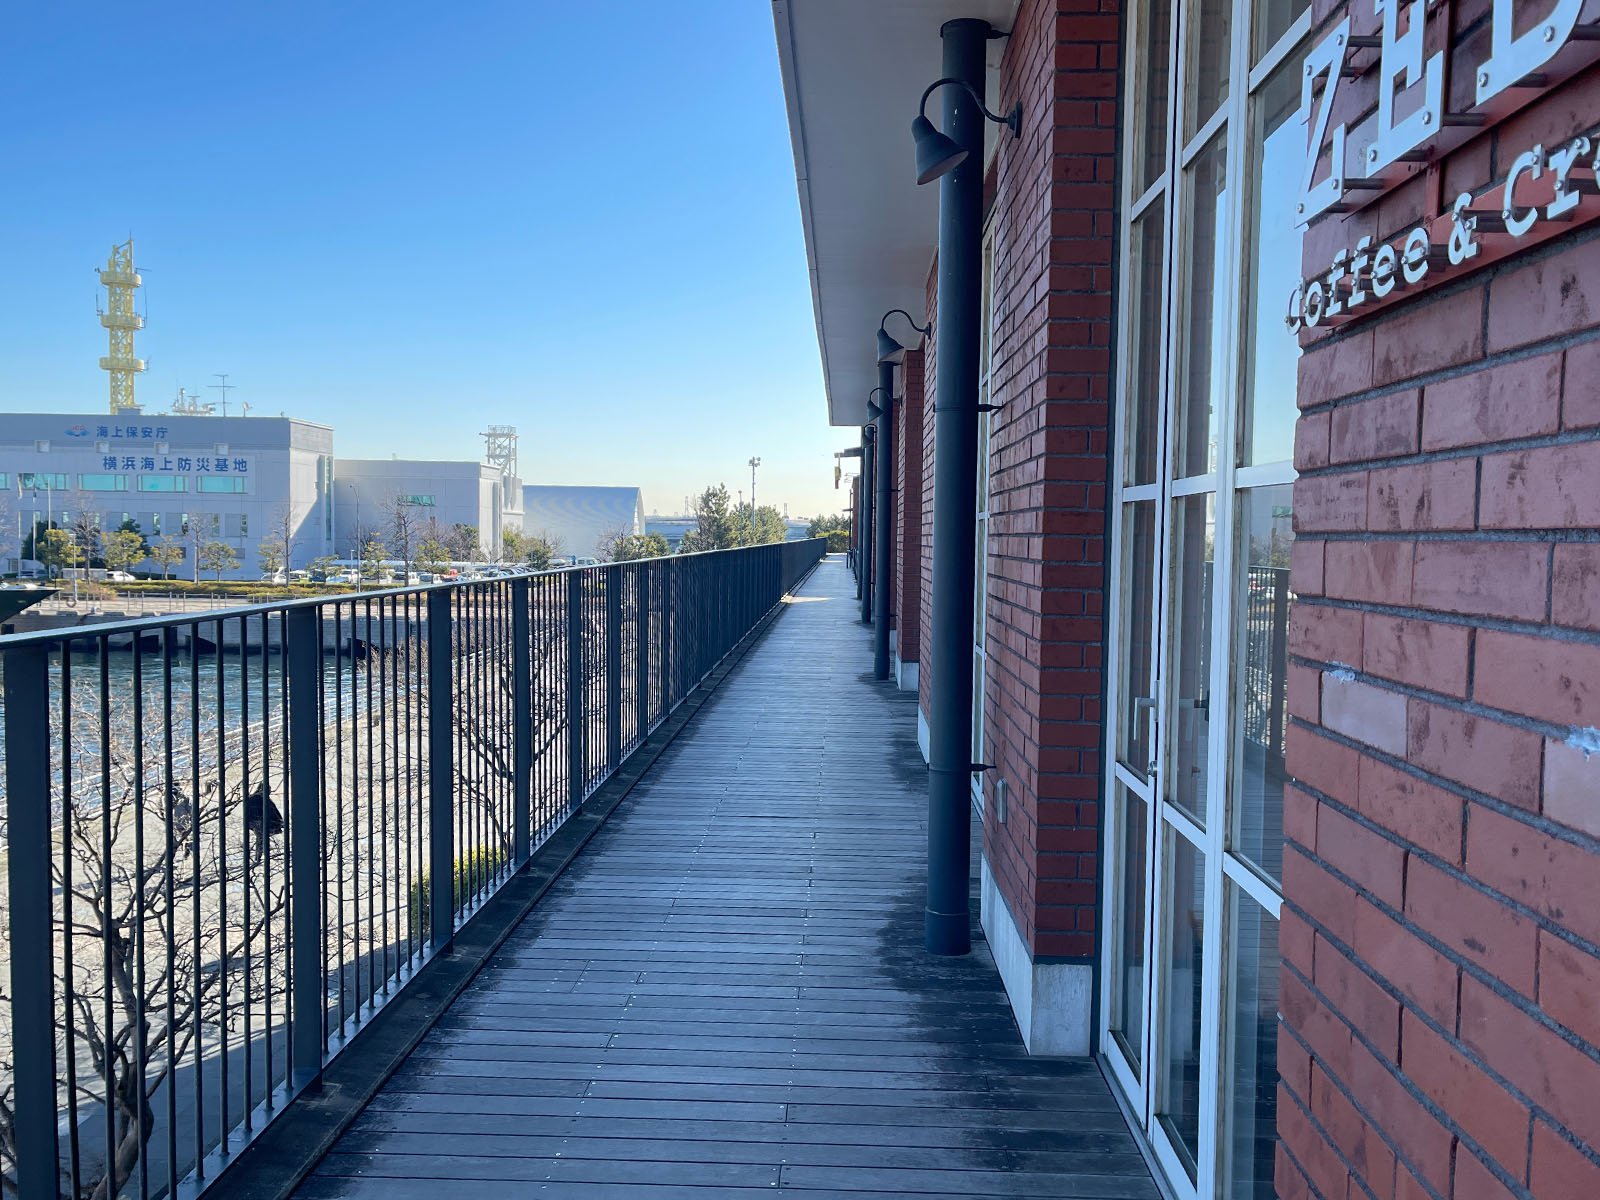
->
xmin=1294 ymin=0 xmax=1600 ymax=227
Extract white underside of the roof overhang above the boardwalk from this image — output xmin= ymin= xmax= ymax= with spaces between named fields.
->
xmin=773 ymin=0 xmax=1019 ymax=426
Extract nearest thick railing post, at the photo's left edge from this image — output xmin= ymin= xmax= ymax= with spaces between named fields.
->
xmin=5 ymin=645 xmax=59 ymax=1200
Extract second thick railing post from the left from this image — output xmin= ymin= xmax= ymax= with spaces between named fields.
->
xmin=283 ymin=608 xmax=326 ymax=1088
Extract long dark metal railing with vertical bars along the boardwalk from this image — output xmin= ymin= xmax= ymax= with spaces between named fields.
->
xmin=0 ymin=539 xmax=826 ymax=1200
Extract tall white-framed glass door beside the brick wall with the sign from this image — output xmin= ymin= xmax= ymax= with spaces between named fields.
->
xmin=1099 ymin=0 xmax=1310 ymax=1200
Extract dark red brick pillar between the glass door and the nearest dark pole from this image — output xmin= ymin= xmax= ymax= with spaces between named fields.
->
xmin=960 ymin=0 xmax=1120 ymax=958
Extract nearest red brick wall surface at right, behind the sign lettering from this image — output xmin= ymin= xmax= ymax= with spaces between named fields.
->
xmin=1277 ymin=58 xmax=1600 ymax=1200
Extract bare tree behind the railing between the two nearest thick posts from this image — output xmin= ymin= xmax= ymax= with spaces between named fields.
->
xmin=0 ymin=688 xmax=286 ymax=1200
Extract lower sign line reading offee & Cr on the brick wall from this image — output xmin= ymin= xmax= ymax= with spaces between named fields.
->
xmin=1285 ymin=130 xmax=1600 ymax=333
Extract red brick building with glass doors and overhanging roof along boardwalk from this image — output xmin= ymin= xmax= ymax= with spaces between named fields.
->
xmin=773 ymin=0 xmax=1600 ymax=1200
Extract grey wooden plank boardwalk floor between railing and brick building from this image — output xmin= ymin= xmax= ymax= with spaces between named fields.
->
xmin=299 ymin=557 xmax=1157 ymax=1200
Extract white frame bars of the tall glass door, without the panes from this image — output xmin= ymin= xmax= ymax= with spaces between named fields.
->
xmin=1096 ymin=0 xmax=1310 ymax=1200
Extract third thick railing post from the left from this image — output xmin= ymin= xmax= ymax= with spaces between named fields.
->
xmin=427 ymin=587 xmax=456 ymax=954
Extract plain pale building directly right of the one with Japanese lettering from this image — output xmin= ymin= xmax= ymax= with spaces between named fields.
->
xmin=333 ymin=458 xmax=523 ymax=558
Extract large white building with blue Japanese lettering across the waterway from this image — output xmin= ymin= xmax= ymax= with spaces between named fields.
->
xmin=0 ymin=410 xmax=334 ymax=578
